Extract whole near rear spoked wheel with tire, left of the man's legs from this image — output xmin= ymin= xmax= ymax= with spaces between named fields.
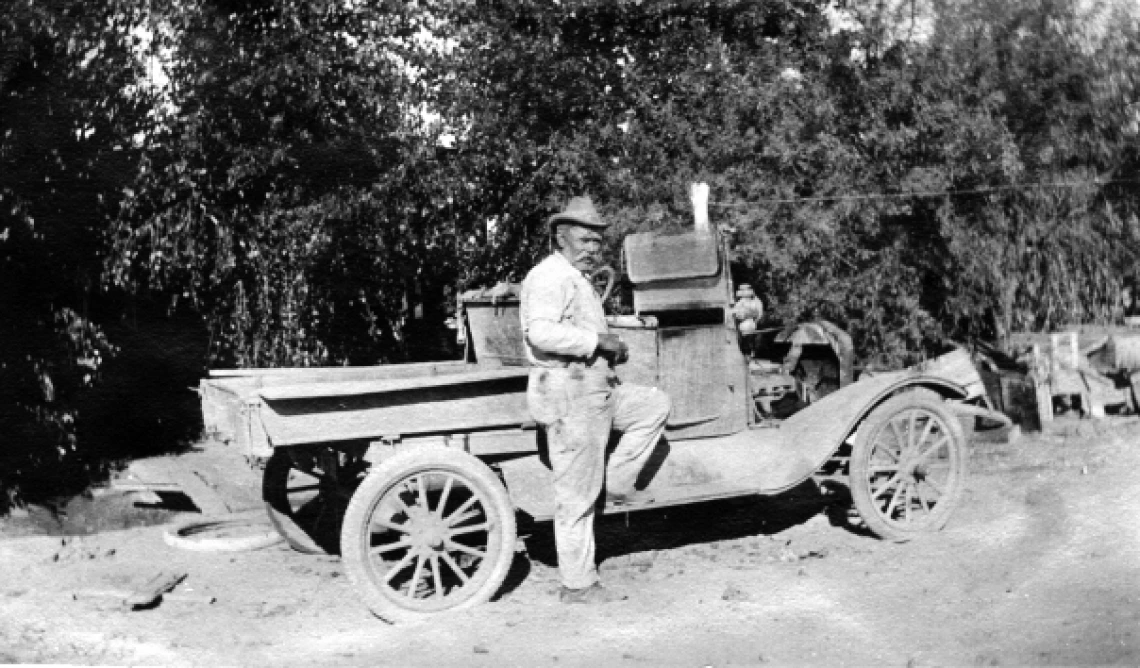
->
xmin=341 ymin=447 xmax=515 ymax=622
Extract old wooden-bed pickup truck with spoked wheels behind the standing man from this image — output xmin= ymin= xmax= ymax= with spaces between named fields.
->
xmin=201 ymin=200 xmax=980 ymax=621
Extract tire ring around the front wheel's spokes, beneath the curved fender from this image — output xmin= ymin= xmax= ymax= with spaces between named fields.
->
xmin=848 ymin=392 xmax=969 ymax=543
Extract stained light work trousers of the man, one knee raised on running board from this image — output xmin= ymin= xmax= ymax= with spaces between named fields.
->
xmin=527 ymin=368 xmax=671 ymax=589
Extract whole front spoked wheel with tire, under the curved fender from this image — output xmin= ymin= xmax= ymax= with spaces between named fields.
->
xmin=849 ymin=392 xmax=968 ymax=540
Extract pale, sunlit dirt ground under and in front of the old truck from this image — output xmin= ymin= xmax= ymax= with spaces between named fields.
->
xmin=0 ymin=418 xmax=1140 ymax=666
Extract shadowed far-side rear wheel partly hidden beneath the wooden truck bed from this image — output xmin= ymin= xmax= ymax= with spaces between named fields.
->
xmin=261 ymin=448 xmax=348 ymax=554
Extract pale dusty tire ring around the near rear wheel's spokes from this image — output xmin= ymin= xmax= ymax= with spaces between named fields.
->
xmin=341 ymin=446 xmax=518 ymax=624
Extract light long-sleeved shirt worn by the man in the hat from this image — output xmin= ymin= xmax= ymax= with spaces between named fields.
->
xmin=519 ymin=252 xmax=609 ymax=367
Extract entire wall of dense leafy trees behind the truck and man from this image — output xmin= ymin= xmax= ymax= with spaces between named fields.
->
xmin=0 ymin=0 xmax=1140 ymax=506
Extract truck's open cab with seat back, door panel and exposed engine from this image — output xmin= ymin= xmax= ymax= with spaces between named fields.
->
xmin=461 ymin=224 xmax=854 ymax=440
